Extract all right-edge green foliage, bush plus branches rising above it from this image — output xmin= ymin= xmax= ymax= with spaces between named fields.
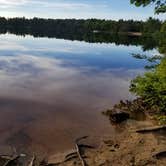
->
xmin=130 ymin=19 xmax=166 ymax=124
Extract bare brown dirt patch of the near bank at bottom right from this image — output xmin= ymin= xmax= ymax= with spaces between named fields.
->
xmin=49 ymin=121 xmax=166 ymax=166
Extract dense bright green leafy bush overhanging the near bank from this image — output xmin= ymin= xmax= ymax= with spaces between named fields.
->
xmin=130 ymin=58 xmax=166 ymax=113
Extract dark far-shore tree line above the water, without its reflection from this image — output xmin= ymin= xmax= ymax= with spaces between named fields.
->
xmin=0 ymin=17 xmax=162 ymax=34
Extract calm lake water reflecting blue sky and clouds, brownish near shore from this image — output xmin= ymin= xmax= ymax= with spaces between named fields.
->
xmin=0 ymin=34 xmax=156 ymax=156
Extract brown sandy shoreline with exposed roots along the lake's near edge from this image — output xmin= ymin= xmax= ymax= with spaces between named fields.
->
xmin=0 ymin=115 xmax=166 ymax=166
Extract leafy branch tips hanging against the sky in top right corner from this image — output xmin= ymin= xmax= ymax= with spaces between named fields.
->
xmin=130 ymin=0 xmax=166 ymax=14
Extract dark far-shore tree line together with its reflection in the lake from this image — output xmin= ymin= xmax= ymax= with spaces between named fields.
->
xmin=0 ymin=17 xmax=164 ymax=49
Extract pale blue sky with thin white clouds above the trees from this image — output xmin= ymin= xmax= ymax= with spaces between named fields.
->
xmin=0 ymin=0 xmax=166 ymax=20
